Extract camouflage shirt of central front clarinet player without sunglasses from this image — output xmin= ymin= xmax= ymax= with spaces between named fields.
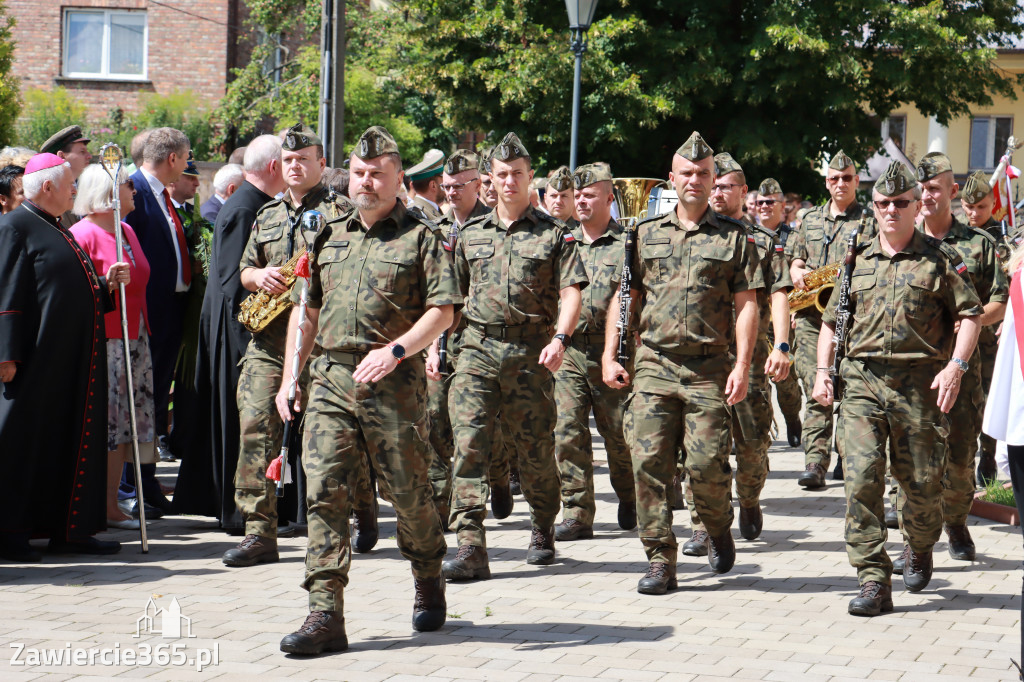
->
xmin=615 ymin=209 xmax=765 ymax=354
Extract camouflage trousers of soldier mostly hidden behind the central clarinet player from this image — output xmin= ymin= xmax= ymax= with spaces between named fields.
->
xmin=686 ymin=368 xmax=774 ymax=532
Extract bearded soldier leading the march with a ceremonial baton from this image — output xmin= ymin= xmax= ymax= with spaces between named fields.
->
xmin=278 ymin=126 xmax=461 ymax=654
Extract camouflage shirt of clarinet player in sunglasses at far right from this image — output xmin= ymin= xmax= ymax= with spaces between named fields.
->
xmin=822 ymin=230 xmax=982 ymax=364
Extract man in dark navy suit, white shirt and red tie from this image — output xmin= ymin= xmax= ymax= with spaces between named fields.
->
xmin=124 ymin=128 xmax=193 ymax=503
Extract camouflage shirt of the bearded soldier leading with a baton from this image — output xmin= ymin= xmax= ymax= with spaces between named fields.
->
xmin=303 ymin=197 xmax=462 ymax=352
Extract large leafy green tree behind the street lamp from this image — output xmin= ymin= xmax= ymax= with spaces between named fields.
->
xmin=385 ymin=0 xmax=1024 ymax=194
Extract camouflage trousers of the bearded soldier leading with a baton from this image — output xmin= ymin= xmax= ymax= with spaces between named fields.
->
xmin=302 ymin=352 xmax=446 ymax=611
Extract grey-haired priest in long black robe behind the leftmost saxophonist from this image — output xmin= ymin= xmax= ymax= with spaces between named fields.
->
xmin=173 ymin=135 xmax=295 ymax=532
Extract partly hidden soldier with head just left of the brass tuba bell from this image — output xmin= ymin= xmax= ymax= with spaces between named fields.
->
xmin=555 ymin=164 xmax=637 ymax=541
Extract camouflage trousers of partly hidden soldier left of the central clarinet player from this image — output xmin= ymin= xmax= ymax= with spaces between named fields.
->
xmin=555 ymin=344 xmax=636 ymax=526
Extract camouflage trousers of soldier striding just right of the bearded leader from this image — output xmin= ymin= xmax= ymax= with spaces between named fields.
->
xmin=449 ymin=327 xmax=559 ymax=547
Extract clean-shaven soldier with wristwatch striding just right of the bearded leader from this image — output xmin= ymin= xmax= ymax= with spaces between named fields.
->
xmin=443 ymin=133 xmax=587 ymax=580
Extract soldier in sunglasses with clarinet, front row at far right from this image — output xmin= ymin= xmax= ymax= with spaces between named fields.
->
xmin=812 ymin=162 xmax=982 ymax=615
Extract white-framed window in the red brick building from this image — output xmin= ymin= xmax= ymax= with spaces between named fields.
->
xmin=63 ymin=9 xmax=147 ymax=80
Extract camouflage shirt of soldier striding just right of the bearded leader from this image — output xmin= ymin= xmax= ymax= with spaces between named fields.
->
xmin=455 ymin=207 xmax=588 ymax=327
